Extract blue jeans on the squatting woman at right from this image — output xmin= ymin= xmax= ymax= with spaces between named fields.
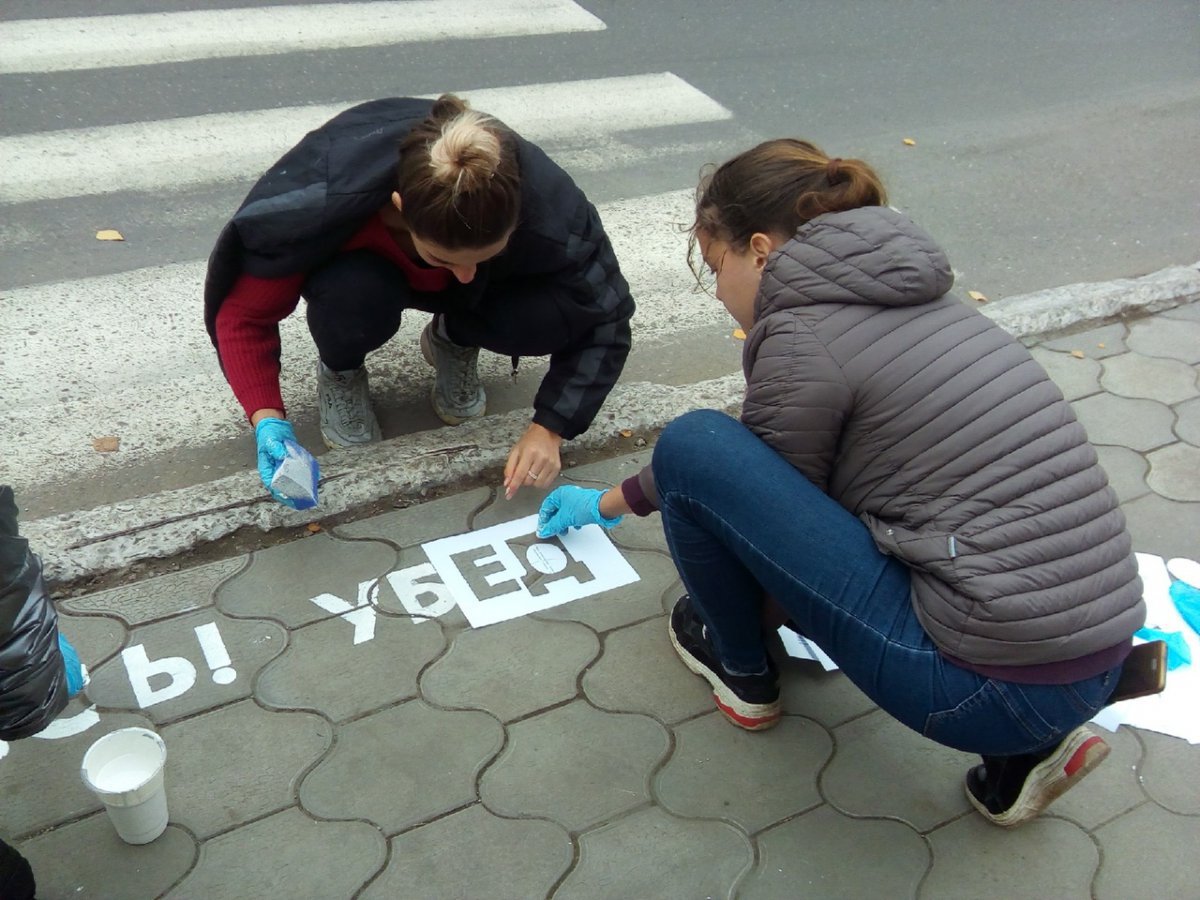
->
xmin=652 ymin=409 xmax=1120 ymax=756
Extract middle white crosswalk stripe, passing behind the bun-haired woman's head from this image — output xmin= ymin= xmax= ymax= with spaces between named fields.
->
xmin=0 ymin=72 xmax=732 ymax=203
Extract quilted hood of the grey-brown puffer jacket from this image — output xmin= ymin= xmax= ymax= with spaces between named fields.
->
xmin=755 ymin=206 xmax=954 ymax=320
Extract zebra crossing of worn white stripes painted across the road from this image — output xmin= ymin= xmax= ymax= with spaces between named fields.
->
xmin=0 ymin=0 xmax=748 ymax=517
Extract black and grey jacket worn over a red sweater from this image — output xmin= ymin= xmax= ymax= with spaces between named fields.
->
xmin=204 ymin=97 xmax=634 ymax=438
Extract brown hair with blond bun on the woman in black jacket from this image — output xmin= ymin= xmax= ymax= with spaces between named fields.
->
xmin=396 ymin=94 xmax=521 ymax=250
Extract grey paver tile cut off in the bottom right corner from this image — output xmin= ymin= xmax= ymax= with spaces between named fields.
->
xmin=1092 ymin=803 xmax=1200 ymax=900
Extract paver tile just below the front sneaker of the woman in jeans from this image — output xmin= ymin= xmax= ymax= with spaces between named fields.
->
xmin=654 ymin=710 xmax=833 ymax=833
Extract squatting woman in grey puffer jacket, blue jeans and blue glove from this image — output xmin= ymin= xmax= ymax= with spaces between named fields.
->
xmin=539 ymin=139 xmax=1145 ymax=826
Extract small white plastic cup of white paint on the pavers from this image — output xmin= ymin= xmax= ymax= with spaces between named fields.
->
xmin=79 ymin=727 xmax=167 ymax=844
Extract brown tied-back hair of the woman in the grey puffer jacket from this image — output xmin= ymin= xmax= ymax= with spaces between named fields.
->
xmin=689 ymin=138 xmax=887 ymax=257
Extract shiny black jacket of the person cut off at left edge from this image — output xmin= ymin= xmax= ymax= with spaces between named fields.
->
xmin=0 ymin=485 xmax=67 ymax=740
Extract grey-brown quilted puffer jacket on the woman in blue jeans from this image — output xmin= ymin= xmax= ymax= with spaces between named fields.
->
xmin=742 ymin=206 xmax=1145 ymax=665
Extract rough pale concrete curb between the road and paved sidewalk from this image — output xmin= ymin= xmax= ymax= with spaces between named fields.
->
xmin=22 ymin=263 xmax=1200 ymax=582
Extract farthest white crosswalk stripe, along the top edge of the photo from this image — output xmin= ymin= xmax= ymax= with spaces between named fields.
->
xmin=0 ymin=0 xmax=605 ymax=73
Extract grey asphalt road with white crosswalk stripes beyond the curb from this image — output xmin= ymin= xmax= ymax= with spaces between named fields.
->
xmin=0 ymin=0 xmax=1200 ymax=517
